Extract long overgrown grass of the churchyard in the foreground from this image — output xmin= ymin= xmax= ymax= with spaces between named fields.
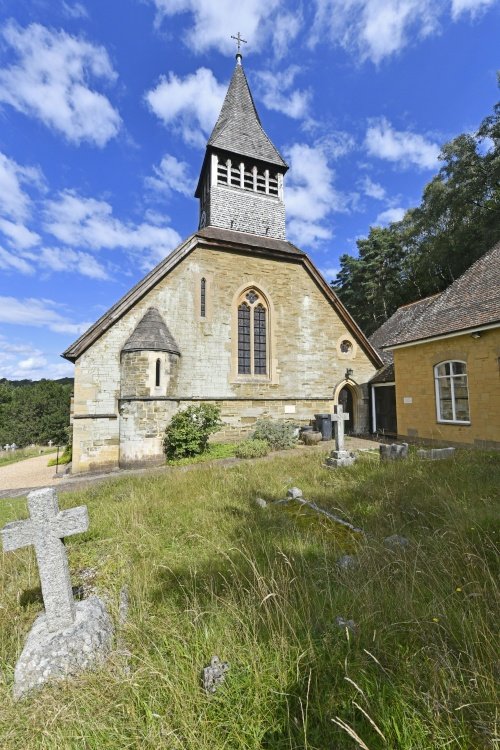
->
xmin=0 ymin=451 xmax=500 ymax=750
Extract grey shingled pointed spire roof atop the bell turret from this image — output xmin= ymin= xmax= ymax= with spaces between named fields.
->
xmin=208 ymin=63 xmax=288 ymax=169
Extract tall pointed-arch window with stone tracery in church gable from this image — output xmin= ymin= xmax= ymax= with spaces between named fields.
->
xmin=238 ymin=289 xmax=269 ymax=375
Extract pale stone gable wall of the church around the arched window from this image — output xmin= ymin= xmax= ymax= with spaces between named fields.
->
xmin=73 ymin=247 xmax=375 ymax=472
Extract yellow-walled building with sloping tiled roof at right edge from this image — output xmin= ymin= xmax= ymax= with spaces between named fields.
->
xmin=371 ymin=243 xmax=500 ymax=449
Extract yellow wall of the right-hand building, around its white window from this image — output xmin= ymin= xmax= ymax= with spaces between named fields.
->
xmin=394 ymin=328 xmax=500 ymax=449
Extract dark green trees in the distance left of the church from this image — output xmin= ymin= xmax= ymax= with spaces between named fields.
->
xmin=0 ymin=378 xmax=73 ymax=447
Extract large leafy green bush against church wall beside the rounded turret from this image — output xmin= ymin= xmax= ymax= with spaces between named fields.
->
xmin=163 ymin=404 xmax=223 ymax=458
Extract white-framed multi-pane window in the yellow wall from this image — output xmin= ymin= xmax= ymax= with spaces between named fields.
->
xmin=434 ymin=360 xmax=470 ymax=424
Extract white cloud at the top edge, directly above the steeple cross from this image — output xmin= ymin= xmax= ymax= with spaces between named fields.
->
xmin=148 ymin=0 xmax=288 ymax=55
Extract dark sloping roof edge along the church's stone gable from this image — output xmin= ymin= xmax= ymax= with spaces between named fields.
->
xmin=62 ymin=227 xmax=382 ymax=367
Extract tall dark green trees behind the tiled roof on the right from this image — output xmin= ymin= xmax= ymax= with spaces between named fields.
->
xmin=332 ymin=87 xmax=500 ymax=335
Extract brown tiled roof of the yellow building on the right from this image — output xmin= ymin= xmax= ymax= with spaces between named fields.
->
xmin=371 ymin=242 xmax=500 ymax=347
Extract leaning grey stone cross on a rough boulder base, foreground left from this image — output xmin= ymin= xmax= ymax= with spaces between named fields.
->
xmin=0 ymin=487 xmax=89 ymax=631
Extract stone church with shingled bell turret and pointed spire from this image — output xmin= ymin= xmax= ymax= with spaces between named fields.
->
xmin=63 ymin=53 xmax=382 ymax=472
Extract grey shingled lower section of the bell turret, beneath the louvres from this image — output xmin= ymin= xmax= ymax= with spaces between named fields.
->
xmin=205 ymin=185 xmax=285 ymax=240
